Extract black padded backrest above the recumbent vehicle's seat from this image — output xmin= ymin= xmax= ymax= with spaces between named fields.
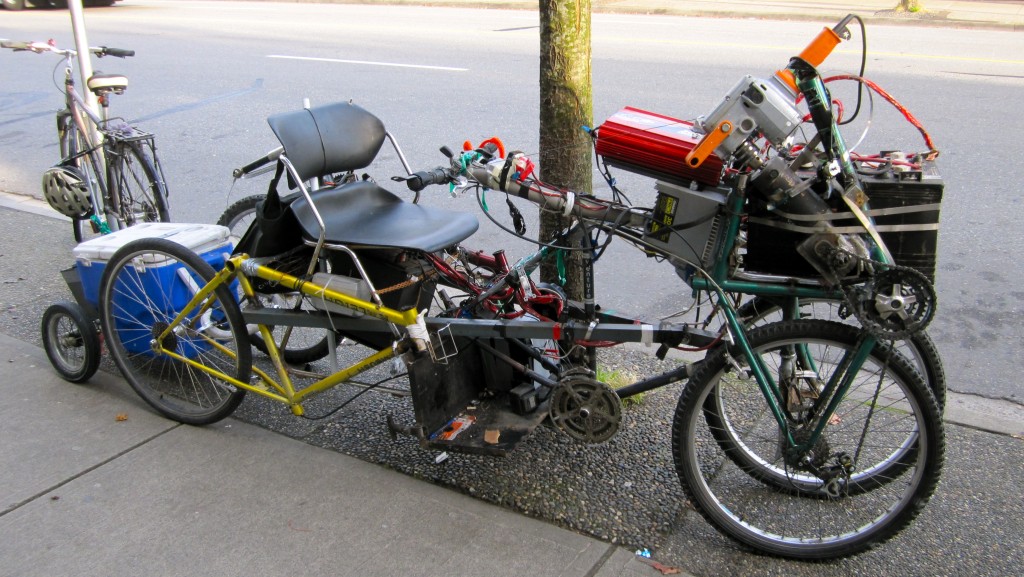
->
xmin=266 ymin=102 xmax=386 ymax=180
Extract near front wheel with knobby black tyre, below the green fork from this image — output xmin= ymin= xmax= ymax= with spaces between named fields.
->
xmin=672 ymin=320 xmax=944 ymax=560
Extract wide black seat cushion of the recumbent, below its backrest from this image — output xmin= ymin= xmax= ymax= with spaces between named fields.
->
xmin=291 ymin=180 xmax=479 ymax=252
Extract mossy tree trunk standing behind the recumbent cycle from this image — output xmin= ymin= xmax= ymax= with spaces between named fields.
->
xmin=540 ymin=0 xmax=594 ymax=300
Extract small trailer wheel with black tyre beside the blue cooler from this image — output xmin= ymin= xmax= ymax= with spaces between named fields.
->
xmin=41 ymin=302 xmax=102 ymax=382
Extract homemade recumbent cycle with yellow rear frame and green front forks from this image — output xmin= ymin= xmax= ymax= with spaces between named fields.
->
xmin=54 ymin=16 xmax=944 ymax=559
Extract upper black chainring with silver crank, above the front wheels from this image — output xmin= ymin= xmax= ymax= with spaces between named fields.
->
xmin=827 ymin=246 xmax=938 ymax=340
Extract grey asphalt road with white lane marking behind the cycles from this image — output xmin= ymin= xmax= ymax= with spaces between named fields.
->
xmin=6 ymin=0 xmax=1024 ymax=403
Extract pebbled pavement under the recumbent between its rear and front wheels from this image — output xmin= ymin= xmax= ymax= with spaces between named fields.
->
xmin=234 ymin=346 xmax=685 ymax=548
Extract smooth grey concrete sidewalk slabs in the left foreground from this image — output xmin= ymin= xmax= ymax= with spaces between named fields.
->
xmin=0 ymin=334 xmax=671 ymax=577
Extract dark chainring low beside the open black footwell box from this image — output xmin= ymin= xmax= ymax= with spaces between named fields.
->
xmin=549 ymin=375 xmax=623 ymax=444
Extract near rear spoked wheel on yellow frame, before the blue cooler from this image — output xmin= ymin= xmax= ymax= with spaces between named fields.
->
xmin=99 ymin=239 xmax=252 ymax=424
